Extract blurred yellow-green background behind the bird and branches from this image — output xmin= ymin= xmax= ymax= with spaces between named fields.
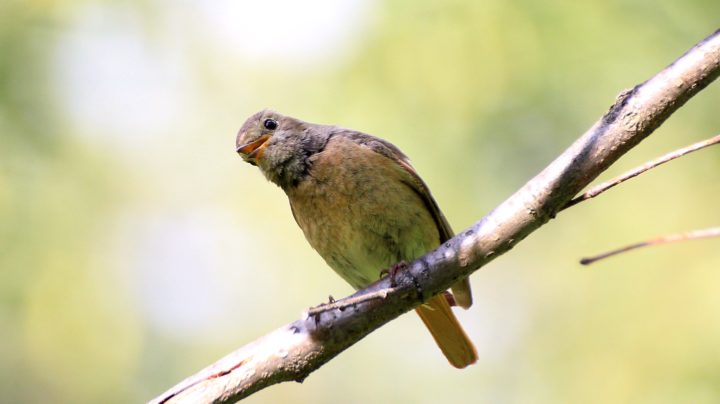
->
xmin=0 ymin=0 xmax=720 ymax=403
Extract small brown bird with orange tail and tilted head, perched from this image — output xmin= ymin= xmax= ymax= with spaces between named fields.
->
xmin=236 ymin=110 xmax=477 ymax=368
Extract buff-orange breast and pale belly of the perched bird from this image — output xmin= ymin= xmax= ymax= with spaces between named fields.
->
xmin=286 ymin=139 xmax=439 ymax=288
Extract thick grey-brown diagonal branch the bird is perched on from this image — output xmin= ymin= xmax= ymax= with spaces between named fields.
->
xmin=152 ymin=30 xmax=720 ymax=403
